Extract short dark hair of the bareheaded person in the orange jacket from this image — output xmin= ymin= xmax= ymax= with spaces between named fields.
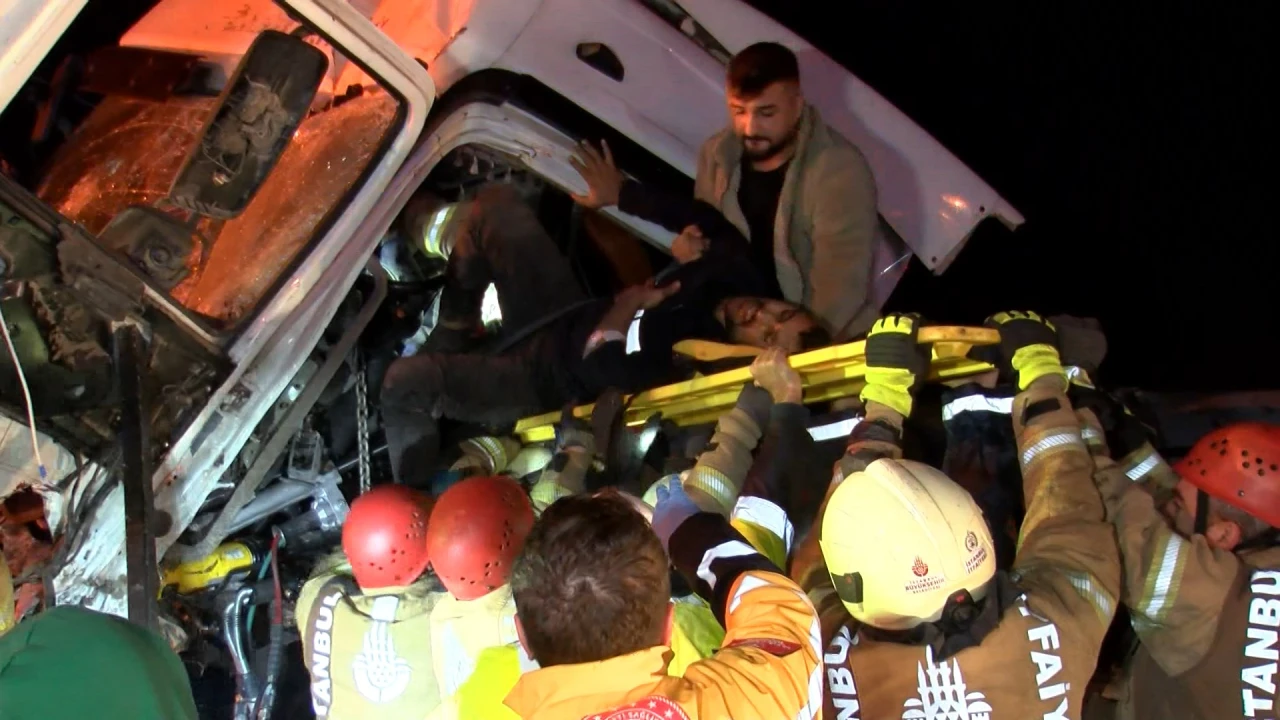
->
xmin=511 ymin=489 xmax=671 ymax=667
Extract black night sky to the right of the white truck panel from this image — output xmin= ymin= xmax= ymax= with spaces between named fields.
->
xmin=751 ymin=0 xmax=1280 ymax=389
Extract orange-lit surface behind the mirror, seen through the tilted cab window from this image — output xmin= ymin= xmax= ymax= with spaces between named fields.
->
xmin=38 ymin=92 xmax=396 ymax=328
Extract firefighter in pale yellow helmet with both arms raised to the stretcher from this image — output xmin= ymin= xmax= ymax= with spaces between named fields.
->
xmin=792 ymin=313 xmax=1120 ymax=719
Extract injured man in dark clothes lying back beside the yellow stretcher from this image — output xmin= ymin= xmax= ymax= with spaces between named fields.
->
xmin=381 ymin=184 xmax=829 ymax=484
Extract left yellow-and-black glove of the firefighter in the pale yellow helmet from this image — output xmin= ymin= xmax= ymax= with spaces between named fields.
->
xmin=859 ymin=315 xmax=929 ymax=418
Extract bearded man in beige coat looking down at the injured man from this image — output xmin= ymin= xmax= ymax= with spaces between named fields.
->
xmin=573 ymin=42 xmax=879 ymax=340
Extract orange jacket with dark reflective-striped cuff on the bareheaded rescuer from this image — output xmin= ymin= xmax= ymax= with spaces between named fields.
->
xmin=506 ymin=512 xmax=822 ymax=720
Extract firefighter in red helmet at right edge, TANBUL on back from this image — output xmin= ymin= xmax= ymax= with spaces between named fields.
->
xmin=1100 ymin=415 xmax=1280 ymax=720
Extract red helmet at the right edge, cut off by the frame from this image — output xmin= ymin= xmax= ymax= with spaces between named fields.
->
xmin=1174 ymin=423 xmax=1280 ymax=528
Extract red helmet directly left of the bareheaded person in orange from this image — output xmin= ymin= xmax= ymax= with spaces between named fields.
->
xmin=426 ymin=477 xmax=534 ymax=600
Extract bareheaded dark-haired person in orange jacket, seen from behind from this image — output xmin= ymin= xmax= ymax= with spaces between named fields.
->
xmin=506 ymin=483 xmax=822 ymax=720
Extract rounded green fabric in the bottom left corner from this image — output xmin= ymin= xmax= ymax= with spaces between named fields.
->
xmin=0 ymin=606 xmax=196 ymax=720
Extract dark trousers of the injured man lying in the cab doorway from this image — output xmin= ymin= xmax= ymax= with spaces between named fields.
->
xmin=381 ymin=184 xmax=585 ymax=484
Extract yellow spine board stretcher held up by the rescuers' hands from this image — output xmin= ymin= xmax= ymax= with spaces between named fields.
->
xmin=516 ymin=327 xmax=1000 ymax=445
